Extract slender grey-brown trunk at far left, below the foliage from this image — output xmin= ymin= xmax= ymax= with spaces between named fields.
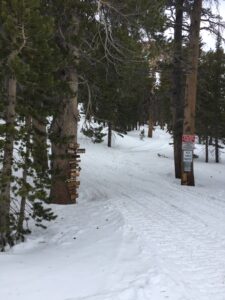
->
xmin=0 ymin=78 xmax=16 ymax=250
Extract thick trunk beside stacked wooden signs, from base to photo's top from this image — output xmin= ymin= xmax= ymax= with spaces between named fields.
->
xmin=50 ymin=1 xmax=80 ymax=204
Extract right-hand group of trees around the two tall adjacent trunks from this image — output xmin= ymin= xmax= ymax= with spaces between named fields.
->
xmin=151 ymin=0 xmax=224 ymax=185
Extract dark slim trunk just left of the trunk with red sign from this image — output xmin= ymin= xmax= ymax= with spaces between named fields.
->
xmin=172 ymin=0 xmax=184 ymax=178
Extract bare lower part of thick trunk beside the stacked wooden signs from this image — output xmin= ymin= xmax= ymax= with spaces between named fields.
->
xmin=50 ymin=69 xmax=78 ymax=204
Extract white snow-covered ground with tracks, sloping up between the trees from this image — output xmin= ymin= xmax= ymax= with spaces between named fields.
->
xmin=0 ymin=129 xmax=225 ymax=300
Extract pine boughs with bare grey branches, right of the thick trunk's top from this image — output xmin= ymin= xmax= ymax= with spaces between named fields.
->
xmin=80 ymin=1 xmax=163 ymax=137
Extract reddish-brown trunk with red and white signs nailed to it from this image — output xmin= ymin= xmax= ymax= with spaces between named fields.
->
xmin=181 ymin=0 xmax=202 ymax=186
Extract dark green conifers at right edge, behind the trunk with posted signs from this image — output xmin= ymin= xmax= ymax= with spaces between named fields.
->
xmin=196 ymin=33 xmax=225 ymax=163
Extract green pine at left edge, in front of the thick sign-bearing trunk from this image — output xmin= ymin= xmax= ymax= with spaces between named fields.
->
xmin=0 ymin=0 xmax=58 ymax=249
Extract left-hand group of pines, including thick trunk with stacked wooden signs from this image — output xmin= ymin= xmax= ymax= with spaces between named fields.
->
xmin=0 ymin=0 xmax=164 ymax=249
